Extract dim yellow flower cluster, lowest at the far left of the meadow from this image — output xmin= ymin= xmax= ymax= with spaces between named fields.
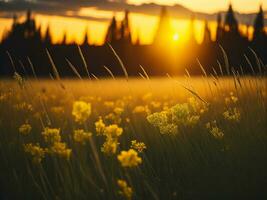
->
xmin=24 ymin=143 xmax=46 ymax=163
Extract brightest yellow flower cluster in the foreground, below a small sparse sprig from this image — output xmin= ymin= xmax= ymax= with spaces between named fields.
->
xmin=117 ymin=149 xmax=142 ymax=167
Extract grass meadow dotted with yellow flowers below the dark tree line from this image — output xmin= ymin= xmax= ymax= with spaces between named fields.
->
xmin=0 ymin=77 xmax=267 ymax=200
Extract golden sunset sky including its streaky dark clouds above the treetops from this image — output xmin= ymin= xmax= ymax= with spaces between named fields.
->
xmin=0 ymin=0 xmax=267 ymax=45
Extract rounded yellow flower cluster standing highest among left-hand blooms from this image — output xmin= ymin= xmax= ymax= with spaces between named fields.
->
xmin=72 ymin=101 xmax=91 ymax=123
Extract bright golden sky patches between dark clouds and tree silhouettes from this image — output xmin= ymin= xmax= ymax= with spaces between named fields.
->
xmin=0 ymin=0 xmax=267 ymax=45
